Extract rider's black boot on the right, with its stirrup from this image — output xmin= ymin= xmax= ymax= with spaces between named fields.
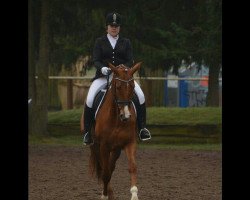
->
xmin=133 ymin=95 xmax=151 ymax=141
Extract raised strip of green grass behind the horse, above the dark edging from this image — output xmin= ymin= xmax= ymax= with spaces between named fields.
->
xmin=48 ymin=107 xmax=222 ymax=125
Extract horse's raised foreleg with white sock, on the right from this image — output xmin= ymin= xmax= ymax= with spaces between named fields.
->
xmin=125 ymin=143 xmax=138 ymax=200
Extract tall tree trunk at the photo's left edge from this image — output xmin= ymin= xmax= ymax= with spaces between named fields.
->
xmin=31 ymin=0 xmax=50 ymax=134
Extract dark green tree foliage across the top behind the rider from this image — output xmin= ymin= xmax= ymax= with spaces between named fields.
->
xmin=31 ymin=0 xmax=222 ymax=71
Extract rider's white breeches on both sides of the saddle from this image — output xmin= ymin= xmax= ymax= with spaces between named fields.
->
xmin=86 ymin=74 xmax=145 ymax=108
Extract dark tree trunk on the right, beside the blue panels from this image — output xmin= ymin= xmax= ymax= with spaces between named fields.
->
xmin=207 ymin=65 xmax=220 ymax=107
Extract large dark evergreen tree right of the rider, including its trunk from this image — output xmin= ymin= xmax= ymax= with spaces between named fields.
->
xmin=122 ymin=0 xmax=222 ymax=106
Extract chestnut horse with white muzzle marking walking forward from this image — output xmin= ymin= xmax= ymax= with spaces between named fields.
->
xmin=90 ymin=62 xmax=141 ymax=200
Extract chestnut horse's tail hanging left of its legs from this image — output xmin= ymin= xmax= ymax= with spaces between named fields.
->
xmin=89 ymin=143 xmax=102 ymax=181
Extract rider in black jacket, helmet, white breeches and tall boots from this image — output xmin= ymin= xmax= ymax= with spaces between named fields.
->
xmin=83 ymin=12 xmax=151 ymax=145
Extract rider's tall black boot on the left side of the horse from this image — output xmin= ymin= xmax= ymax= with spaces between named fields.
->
xmin=83 ymin=104 xmax=94 ymax=145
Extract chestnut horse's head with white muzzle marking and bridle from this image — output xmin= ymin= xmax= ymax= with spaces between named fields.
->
xmin=109 ymin=62 xmax=142 ymax=121
